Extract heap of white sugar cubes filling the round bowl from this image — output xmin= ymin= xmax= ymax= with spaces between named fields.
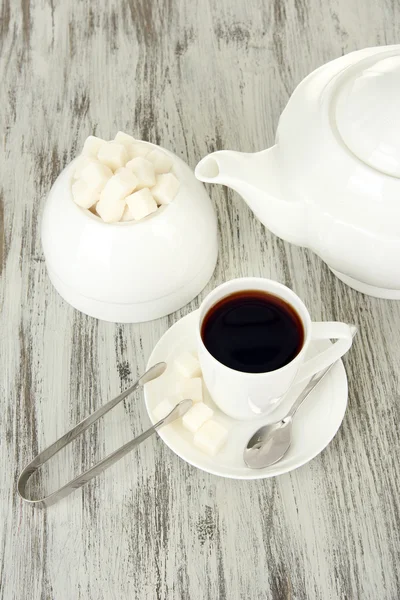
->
xmin=72 ymin=131 xmax=179 ymax=223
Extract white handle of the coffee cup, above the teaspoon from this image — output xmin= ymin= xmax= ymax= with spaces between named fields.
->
xmin=295 ymin=321 xmax=356 ymax=383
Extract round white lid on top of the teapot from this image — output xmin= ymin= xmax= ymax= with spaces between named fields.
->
xmin=335 ymin=51 xmax=400 ymax=178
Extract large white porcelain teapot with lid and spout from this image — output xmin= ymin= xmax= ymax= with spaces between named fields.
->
xmin=195 ymin=45 xmax=400 ymax=299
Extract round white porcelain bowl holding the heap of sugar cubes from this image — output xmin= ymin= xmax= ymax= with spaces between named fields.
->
xmin=41 ymin=142 xmax=218 ymax=323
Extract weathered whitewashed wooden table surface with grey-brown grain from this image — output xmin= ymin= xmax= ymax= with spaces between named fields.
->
xmin=0 ymin=0 xmax=400 ymax=600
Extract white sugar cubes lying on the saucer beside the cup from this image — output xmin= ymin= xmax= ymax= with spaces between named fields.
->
xmin=153 ymin=352 xmax=228 ymax=456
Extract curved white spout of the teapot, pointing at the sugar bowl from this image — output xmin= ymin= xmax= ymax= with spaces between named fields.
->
xmin=195 ymin=145 xmax=307 ymax=246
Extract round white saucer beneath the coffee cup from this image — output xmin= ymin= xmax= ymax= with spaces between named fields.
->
xmin=145 ymin=311 xmax=347 ymax=479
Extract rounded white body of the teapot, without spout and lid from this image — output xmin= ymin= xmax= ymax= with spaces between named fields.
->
xmin=276 ymin=48 xmax=400 ymax=298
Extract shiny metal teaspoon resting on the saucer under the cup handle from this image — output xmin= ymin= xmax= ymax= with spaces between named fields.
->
xmin=243 ymin=326 xmax=357 ymax=469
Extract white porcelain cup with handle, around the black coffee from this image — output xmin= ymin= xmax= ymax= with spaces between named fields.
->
xmin=197 ymin=277 xmax=352 ymax=420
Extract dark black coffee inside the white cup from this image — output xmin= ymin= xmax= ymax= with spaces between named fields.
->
xmin=201 ymin=290 xmax=304 ymax=373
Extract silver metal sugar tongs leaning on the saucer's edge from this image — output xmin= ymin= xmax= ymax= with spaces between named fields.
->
xmin=17 ymin=362 xmax=193 ymax=508
